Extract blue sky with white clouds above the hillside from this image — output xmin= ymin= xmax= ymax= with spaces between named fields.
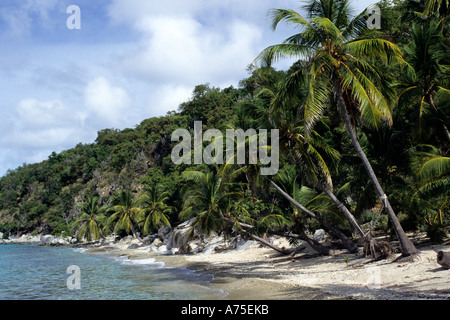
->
xmin=0 ymin=0 xmax=376 ymax=176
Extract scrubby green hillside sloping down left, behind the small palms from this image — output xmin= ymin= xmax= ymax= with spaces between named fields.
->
xmin=0 ymin=81 xmax=253 ymax=234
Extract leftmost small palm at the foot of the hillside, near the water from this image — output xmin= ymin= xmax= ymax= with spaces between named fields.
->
xmin=73 ymin=197 xmax=106 ymax=241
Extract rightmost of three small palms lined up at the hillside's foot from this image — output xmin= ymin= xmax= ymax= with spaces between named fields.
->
xmin=139 ymin=185 xmax=173 ymax=235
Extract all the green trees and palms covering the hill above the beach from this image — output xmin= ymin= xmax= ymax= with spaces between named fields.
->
xmin=0 ymin=0 xmax=450 ymax=257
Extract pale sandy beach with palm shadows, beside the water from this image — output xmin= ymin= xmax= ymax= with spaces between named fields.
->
xmin=87 ymin=238 xmax=450 ymax=300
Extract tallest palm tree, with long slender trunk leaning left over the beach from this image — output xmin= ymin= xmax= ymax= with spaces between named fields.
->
xmin=257 ymin=0 xmax=417 ymax=256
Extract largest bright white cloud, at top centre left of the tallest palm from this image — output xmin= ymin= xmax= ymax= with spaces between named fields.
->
xmin=118 ymin=16 xmax=262 ymax=86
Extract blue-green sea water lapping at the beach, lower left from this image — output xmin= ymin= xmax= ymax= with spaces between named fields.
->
xmin=0 ymin=245 xmax=224 ymax=300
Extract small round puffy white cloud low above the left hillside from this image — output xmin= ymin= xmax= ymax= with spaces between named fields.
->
xmin=84 ymin=77 xmax=131 ymax=126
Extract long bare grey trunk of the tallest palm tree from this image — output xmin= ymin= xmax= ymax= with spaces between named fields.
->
xmin=333 ymin=80 xmax=417 ymax=257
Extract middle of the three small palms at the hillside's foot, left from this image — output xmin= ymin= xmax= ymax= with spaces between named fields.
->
xmin=109 ymin=190 xmax=141 ymax=240
